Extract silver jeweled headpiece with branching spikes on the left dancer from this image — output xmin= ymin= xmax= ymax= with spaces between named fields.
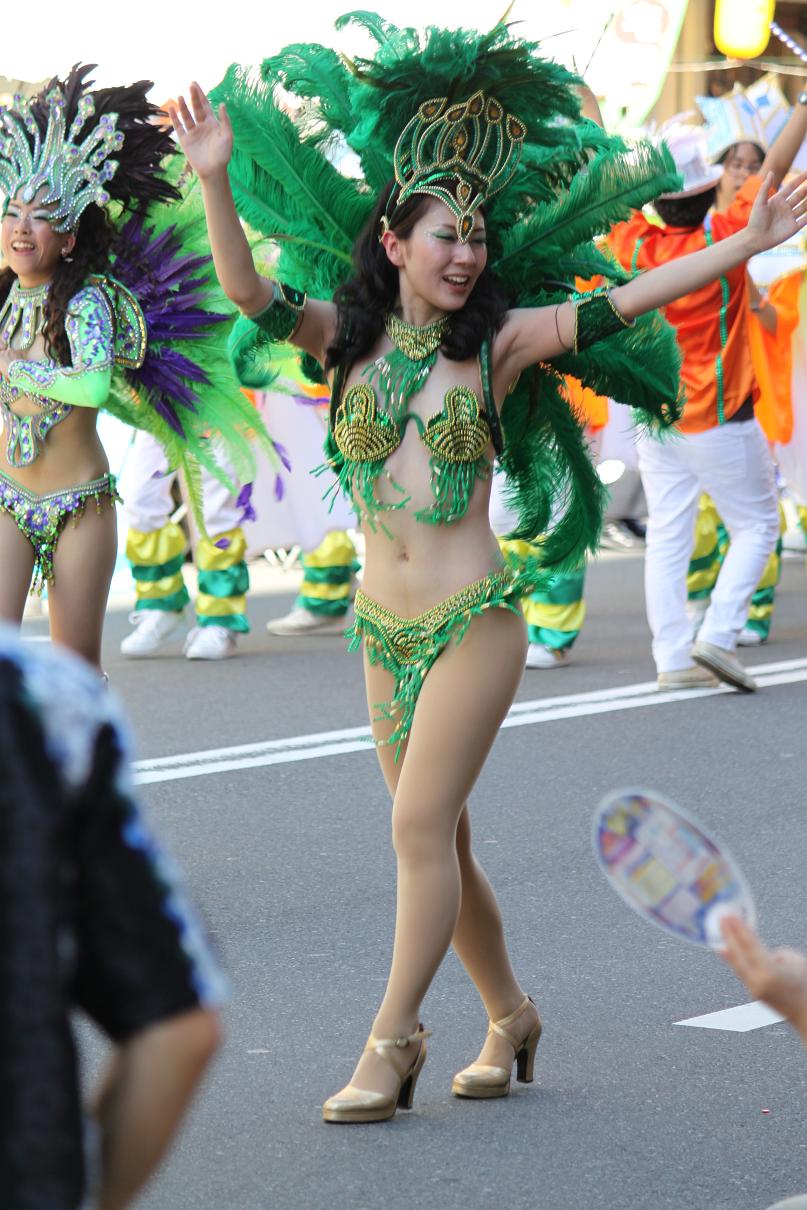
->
xmin=0 ymin=88 xmax=123 ymax=231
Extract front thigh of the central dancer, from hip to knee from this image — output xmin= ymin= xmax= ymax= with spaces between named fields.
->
xmin=393 ymin=609 xmax=526 ymax=835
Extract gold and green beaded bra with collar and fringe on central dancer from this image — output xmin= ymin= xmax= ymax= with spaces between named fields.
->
xmin=332 ymin=313 xmax=491 ymax=526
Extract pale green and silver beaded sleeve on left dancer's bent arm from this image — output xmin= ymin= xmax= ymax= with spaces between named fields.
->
xmin=8 ymin=286 xmax=115 ymax=408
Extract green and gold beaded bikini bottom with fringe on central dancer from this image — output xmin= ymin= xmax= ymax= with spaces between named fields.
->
xmin=347 ymin=569 xmax=541 ymax=760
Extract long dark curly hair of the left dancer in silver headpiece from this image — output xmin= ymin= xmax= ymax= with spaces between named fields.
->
xmin=0 ymin=206 xmax=115 ymax=365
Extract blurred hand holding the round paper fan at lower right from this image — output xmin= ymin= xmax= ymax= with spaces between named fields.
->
xmin=721 ymin=916 xmax=807 ymax=1045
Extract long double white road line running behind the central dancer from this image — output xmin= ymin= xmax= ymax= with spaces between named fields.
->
xmin=134 ymin=659 xmax=807 ymax=785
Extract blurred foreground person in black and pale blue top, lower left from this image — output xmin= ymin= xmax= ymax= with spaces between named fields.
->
xmin=0 ymin=627 xmax=223 ymax=1210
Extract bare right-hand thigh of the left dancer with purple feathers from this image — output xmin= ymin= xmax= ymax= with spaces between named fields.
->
xmin=48 ymin=501 xmax=117 ymax=667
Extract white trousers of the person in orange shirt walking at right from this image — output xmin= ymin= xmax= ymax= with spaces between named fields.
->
xmin=639 ymin=420 xmax=779 ymax=673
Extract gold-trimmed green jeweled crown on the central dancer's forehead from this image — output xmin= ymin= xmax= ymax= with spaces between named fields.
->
xmin=386 ymin=92 xmax=526 ymax=243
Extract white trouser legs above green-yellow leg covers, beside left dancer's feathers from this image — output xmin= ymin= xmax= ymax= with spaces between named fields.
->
xmin=119 ymin=430 xmax=242 ymax=537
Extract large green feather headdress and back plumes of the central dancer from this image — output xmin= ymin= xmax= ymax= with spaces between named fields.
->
xmin=212 ymin=12 xmax=680 ymax=566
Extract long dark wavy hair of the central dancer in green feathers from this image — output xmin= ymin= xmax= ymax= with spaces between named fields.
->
xmin=325 ymin=182 xmax=509 ymax=370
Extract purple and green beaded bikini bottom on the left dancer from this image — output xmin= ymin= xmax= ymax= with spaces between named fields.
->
xmin=0 ymin=471 xmax=121 ymax=593
